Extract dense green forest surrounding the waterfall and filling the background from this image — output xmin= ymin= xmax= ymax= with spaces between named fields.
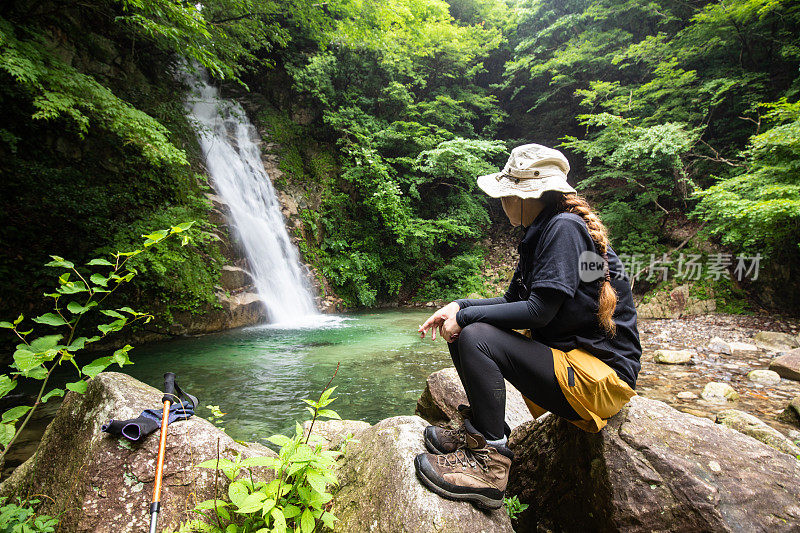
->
xmin=0 ymin=0 xmax=800 ymax=328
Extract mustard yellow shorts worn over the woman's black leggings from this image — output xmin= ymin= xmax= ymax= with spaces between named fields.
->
xmin=525 ymin=348 xmax=636 ymax=433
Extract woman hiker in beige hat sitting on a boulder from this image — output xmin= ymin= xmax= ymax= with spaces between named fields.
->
xmin=414 ymin=144 xmax=642 ymax=509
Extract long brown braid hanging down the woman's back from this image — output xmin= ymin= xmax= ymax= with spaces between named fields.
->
xmin=543 ymin=191 xmax=617 ymax=337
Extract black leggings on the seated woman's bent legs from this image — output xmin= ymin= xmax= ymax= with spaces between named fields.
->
xmin=447 ymin=322 xmax=581 ymax=440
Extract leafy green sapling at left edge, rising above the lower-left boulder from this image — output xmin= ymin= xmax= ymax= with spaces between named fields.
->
xmin=0 ymin=222 xmax=194 ymax=461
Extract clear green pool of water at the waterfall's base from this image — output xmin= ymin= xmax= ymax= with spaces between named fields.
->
xmin=122 ymin=310 xmax=451 ymax=441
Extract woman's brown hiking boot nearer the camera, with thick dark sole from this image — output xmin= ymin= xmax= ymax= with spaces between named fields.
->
xmin=414 ymin=420 xmax=514 ymax=509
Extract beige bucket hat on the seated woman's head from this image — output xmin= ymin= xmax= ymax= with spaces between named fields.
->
xmin=478 ymin=144 xmax=576 ymax=198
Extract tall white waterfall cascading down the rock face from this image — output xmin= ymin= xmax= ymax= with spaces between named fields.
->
xmin=184 ymin=74 xmax=318 ymax=325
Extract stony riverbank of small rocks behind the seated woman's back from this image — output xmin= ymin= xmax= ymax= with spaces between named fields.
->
xmin=636 ymin=313 xmax=800 ymax=439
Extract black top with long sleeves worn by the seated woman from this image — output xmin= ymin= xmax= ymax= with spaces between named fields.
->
xmin=456 ymin=205 xmax=642 ymax=389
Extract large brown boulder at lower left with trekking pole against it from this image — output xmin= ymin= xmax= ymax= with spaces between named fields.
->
xmin=0 ymin=372 xmax=275 ymax=533
